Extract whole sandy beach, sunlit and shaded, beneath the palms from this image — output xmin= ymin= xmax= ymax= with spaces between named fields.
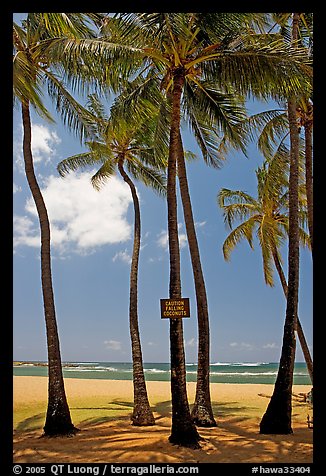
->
xmin=14 ymin=376 xmax=313 ymax=463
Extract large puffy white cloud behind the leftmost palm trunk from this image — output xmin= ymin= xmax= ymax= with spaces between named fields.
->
xmin=15 ymin=171 xmax=131 ymax=253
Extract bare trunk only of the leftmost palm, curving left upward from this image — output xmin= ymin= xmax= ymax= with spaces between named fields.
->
xmin=22 ymin=103 xmax=78 ymax=436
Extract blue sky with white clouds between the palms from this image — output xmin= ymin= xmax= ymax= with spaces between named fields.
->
xmin=13 ymin=12 xmax=313 ymax=363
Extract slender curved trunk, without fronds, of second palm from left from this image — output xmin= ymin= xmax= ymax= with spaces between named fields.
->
xmin=118 ymin=159 xmax=155 ymax=426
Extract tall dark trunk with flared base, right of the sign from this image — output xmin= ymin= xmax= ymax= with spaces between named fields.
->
xmin=260 ymin=13 xmax=299 ymax=434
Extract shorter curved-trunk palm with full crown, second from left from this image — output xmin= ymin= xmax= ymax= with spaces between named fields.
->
xmin=58 ymin=95 xmax=165 ymax=426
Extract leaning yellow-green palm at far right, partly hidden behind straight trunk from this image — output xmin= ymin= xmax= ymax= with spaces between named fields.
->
xmin=218 ymin=151 xmax=313 ymax=382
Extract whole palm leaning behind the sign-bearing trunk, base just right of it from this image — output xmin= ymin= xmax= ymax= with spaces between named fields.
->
xmin=111 ymin=74 xmax=250 ymax=427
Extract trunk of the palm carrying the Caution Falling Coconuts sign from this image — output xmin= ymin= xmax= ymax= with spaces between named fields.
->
xmin=167 ymin=69 xmax=200 ymax=448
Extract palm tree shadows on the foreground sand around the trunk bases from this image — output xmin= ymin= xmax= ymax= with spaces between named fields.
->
xmin=14 ymin=397 xmax=312 ymax=463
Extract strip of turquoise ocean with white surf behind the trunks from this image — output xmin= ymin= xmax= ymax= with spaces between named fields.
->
xmin=13 ymin=362 xmax=311 ymax=385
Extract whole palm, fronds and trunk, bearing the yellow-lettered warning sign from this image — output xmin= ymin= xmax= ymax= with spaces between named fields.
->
xmin=57 ymin=13 xmax=310 ymax=446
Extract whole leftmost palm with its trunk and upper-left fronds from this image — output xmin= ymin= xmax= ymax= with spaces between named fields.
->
xmin=13 ymin=13 xmax=98 ymax=436
